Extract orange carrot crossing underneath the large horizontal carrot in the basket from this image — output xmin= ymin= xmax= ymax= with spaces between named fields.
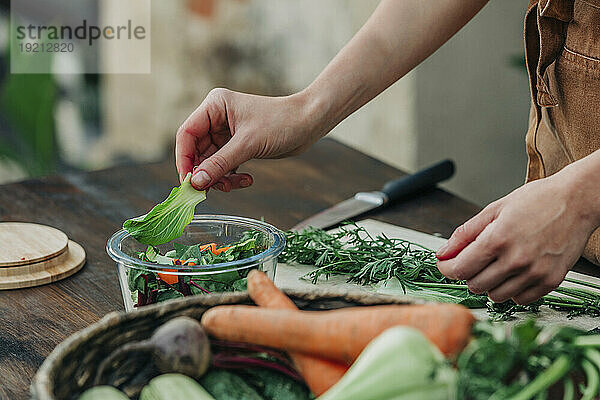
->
xmin=248 ymin=269 xmax=348 ymax=396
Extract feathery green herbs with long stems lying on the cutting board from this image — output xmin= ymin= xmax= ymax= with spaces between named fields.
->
xmin=279 ymin=222 xmax=600 ymax=320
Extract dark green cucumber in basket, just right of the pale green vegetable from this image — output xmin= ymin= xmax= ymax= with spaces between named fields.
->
xmin=200 ymin=369 xmax=264 ymax=400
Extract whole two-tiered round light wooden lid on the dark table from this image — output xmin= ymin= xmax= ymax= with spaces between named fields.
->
xmin=0 ymin=222 xmax=85 ymax=290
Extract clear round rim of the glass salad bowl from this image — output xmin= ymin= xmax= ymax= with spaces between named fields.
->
xmin=106 ymin=214 xmax=286 ymax=275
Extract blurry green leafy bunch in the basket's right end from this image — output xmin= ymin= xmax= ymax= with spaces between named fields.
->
xmin=457 ymin=320 xmax=600 ymax=400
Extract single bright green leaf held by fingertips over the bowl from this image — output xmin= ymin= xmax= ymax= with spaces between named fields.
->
xmin=123 ymin=173 xmax=206 ymax=246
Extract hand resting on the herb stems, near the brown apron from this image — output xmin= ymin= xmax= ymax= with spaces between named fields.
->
xmin=437 ymin=161 xmax=600 ymax=304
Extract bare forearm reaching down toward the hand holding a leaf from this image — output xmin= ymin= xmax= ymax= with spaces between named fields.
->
xmin=301 ymin=0 xmax=487 ymax=135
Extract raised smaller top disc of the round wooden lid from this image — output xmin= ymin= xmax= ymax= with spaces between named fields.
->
xmin=0 ymin=222 xmax=69 ymax=269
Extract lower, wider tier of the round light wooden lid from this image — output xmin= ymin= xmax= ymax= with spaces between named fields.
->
xmin=0 ymin=240 xmax=85 ymax=290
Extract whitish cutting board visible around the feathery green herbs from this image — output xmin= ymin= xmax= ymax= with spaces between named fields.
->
xmin=275 ymin=219 xmax=600 ymax=330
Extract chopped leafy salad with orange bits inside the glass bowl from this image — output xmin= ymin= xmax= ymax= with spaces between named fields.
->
xmin=127 ymin=232 xmax=264 ymax=307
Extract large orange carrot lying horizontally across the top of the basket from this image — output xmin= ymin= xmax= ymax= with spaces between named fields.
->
xmin=202 ymin=304 xmax=474 ymax=365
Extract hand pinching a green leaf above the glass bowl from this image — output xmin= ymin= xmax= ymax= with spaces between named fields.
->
xmin=175 ymin=89 xmax=327 ymax=192
